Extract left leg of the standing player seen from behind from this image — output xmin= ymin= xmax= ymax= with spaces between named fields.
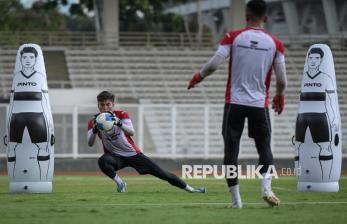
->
xmin=222 ymin=104 xmax=246 ymax=208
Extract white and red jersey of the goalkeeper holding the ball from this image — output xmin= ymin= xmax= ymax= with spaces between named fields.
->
xmin=88 ymin=110 xmax=141 ymax=156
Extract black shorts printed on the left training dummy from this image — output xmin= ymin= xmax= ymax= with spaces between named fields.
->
xmin=10 ymin=112 xmax=48 ymax=143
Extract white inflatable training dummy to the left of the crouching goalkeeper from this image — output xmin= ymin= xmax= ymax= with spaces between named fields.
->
xmin=6 ymin=44 xmax=55 ymax=193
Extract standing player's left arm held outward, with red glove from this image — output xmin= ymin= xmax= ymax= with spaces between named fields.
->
xmin=188 ymin=45 xmax=230 ymax=89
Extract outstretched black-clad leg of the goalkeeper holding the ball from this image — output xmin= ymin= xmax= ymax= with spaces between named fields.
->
xmin=127 ymin=153 xmax=205 ymax=193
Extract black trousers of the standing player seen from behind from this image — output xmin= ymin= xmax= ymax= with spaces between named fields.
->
xmin=222 ymin=104 xmax=273 ymax=187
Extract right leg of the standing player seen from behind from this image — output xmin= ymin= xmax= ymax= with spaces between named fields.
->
xmin=248 ymin=108 xmax=280 ymax=206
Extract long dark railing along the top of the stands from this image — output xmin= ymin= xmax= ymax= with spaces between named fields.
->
xmin=0 ymin=31 xmax=347 ymax=49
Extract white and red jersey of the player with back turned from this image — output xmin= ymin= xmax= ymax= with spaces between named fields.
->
xmin=217 ymin=27 xmax=284 ymax=107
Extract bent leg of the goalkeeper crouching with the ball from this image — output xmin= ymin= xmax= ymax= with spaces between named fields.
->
xmin=98 ymin=153 xmax=126 ymax=192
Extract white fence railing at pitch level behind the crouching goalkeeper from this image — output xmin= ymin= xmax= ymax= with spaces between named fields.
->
xmin=0 ymin=104 xmax=347 ymax=159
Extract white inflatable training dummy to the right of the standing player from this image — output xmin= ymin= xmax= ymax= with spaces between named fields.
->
xmin=295 ymin=44 xmax=341 ymax=192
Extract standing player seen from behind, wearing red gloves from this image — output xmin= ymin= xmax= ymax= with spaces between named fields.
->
xmin=188 ymin=0 xmax=287 ymax=208
